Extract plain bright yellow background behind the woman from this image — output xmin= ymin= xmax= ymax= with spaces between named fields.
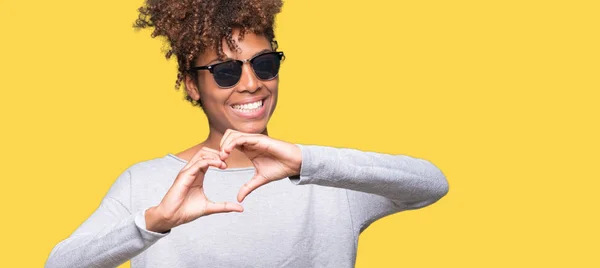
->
xmin=0 ymin=0 xmax=600 ymax=268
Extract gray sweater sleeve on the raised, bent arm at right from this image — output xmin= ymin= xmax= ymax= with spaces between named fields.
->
xmin=290 ymin=144 xmax=449 ymax=232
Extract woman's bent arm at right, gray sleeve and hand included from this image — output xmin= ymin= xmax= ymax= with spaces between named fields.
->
xmin=219 ymin=129 xmax=448 ymax=231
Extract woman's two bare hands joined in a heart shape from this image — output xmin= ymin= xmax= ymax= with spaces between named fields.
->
xmin=146 ymin=130 xmax=302 ymax=232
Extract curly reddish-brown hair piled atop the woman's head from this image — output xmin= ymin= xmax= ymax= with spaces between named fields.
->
xmin=133 ymin=0 xmax=283 ymax=106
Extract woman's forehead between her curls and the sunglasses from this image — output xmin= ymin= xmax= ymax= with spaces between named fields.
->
xmin=196 ymin=30 xmax=271 ymax=65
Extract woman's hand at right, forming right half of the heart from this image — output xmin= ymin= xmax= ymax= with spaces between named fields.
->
xmin=219 ymin=129 xmax=302 ymax=202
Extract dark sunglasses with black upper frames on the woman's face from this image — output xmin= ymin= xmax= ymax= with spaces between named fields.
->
xmin=190 ymin=51 xmax=285 ymax=88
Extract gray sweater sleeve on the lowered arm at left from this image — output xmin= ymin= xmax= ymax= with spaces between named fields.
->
xmin=45 ymin=169 xmax=170 ymax=268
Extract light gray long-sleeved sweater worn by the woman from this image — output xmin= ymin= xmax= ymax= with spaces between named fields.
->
xmin=45 ymin=145 xmax=448 ymax=268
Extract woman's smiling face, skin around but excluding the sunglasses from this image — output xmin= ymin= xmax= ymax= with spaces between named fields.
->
xmin=185 ymin=30 xmax=279 ymax=134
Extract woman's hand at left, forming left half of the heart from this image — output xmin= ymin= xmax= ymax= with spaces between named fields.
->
xmin=145 ymin=147 xmax=244 ymax=233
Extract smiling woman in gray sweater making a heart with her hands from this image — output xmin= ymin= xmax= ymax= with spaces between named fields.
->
xmin=46 ymin=0 xmax=448 ymax=268
